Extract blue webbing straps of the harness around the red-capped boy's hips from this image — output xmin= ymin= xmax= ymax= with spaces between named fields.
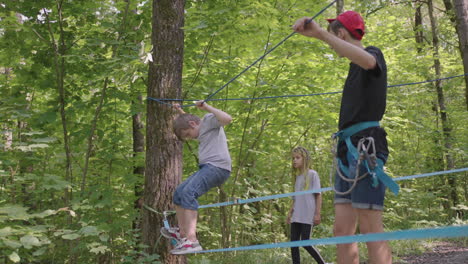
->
xmin=335 ymin=121 xmax=400 ymax=195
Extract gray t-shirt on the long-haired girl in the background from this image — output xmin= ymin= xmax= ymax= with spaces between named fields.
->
xmin=291 ymin=170 xmax=320 ymax=225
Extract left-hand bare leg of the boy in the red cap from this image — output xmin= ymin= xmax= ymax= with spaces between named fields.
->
xmin=333 ymin=203 xmax=359 ymax=264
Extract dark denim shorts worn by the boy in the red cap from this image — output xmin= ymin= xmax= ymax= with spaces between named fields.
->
xmin=335 ymin=127 xmax=388 ymax=210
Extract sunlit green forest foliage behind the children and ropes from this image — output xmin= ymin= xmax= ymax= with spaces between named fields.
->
xmin=0 ymin=0 xmax=468 ymax=263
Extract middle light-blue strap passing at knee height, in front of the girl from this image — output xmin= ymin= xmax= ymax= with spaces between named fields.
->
xmin=198 ymin=167 xmax=468 ymax=209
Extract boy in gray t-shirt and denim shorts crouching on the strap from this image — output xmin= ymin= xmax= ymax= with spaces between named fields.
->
xmin=161 ymin=101 xmax=232 ymax=254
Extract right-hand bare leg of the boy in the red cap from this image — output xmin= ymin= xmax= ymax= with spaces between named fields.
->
xmin=357 ymin=209 xmax=392 ymax=264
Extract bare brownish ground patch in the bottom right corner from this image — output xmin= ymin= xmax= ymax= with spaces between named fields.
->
xmin=396 ymin=241 xmax=468 ymax=264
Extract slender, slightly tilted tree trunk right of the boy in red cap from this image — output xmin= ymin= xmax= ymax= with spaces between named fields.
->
xmin=427 ymin=0 xmax=458 ymax=217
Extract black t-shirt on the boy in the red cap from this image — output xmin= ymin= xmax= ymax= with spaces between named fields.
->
xmin=338 ymin=46 xmax=387 ymax=130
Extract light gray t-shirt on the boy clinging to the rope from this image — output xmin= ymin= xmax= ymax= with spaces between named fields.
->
xmin=198 ymin=113 xmax=231 ymax=171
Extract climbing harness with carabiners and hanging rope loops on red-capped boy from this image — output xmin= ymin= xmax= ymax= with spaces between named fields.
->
xmin=330 ymin=121 xmax=400 ymax=195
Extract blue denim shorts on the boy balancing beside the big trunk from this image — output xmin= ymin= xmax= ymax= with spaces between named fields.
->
xmin=173 ymin=164 xmax=231 ymax=210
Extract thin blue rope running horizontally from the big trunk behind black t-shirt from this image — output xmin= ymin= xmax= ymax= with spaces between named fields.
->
xmin=147 ymin=73 xmax=468 ymax=107
